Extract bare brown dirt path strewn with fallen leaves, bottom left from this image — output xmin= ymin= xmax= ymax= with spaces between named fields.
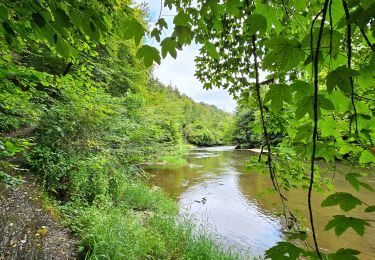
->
xmin=0 ymin=180 xmax=78 ymax=260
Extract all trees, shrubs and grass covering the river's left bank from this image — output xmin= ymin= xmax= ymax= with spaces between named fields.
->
xmin=0 ymin=1 xmax=238 ymax=259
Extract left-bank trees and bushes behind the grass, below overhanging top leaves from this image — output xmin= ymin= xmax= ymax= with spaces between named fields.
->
xmin=0 ymin=23 xmax=234 ymax=201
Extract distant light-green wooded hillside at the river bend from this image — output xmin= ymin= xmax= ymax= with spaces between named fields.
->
xmin=148 ymin=80 xmax=234 ymax=146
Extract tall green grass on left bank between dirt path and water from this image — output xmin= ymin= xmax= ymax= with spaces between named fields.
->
xmin=64 ymin=179 xmax=240 ymax=259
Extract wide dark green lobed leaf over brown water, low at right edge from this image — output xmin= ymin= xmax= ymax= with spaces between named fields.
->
xmin=324 ymin=215 xmax=370 ymax=236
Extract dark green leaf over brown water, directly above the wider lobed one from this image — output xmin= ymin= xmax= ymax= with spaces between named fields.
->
xmin=321 ymin=192 xmax=362 ymax=211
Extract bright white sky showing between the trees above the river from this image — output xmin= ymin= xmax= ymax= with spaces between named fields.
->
xmin=135 ymin=0 xmax=236 ymax=112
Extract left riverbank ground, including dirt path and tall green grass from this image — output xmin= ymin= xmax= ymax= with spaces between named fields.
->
xmin=0 ymin=146 xmax=243 ymax=259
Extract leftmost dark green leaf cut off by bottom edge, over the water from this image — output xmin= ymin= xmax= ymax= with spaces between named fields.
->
xmin=265 ymin=242 xmax=306 ymax=260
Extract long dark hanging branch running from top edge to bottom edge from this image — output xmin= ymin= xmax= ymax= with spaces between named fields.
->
xmin=307 ymin=0 xmax=329 ymax=259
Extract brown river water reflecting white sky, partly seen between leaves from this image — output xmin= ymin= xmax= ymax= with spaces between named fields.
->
xmin=148 ymin=146 xmax=375 ymax=259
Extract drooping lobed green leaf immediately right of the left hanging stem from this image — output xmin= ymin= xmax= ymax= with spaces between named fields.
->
xmin=264 ymin=84 xmax=292 ymax=113
